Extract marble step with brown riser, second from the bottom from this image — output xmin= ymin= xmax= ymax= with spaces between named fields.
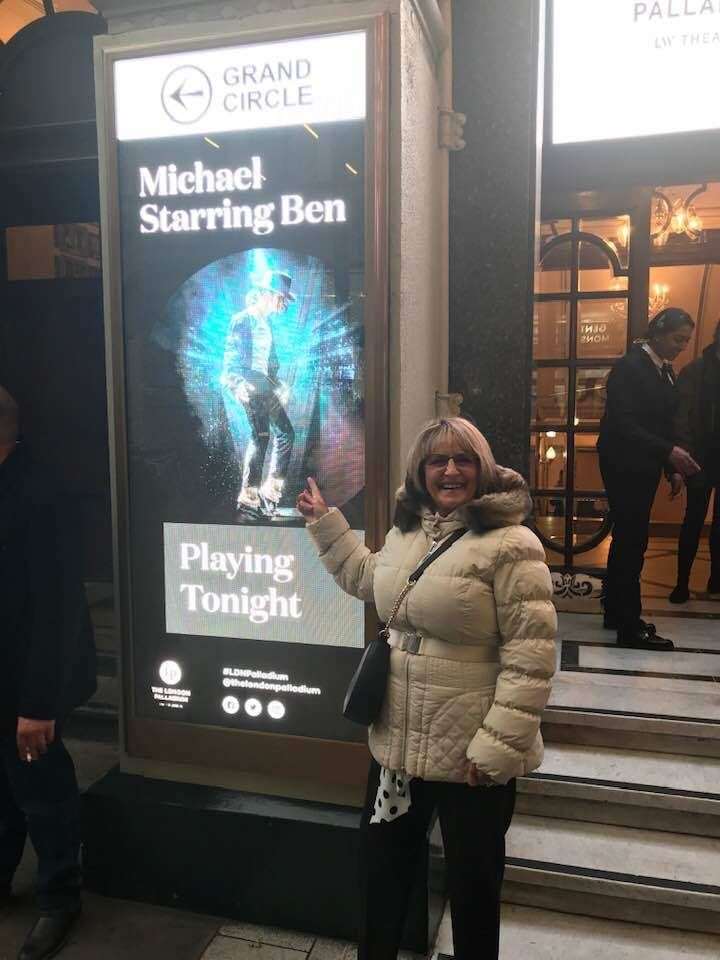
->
xmin=503 ymin=814 xmax=720 ymax=934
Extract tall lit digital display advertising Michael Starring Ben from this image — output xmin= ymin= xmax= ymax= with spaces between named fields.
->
xmin=97 ymin=20 xmax=384 ymax=780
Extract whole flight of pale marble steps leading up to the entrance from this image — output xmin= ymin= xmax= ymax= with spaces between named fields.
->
xmin=436 ymin=614 xmax=720 ymax=960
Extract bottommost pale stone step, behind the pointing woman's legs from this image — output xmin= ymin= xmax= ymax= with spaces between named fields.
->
xmin=437 ymin=904 xmax=718 ymax=960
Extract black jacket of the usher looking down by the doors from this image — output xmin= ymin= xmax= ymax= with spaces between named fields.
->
xmin=598 ymin=344 xmax=677 ymax=473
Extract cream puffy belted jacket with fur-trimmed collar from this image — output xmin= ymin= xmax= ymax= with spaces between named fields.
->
xmin=308 ymin=470 xmax=557 ymax=783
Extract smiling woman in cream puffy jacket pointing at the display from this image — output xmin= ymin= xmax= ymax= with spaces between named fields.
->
xmin=298 ymin=418 xmax=557 ymax=960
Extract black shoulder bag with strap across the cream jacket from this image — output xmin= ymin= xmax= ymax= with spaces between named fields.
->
xmin=343 ymin=529 xmax=467 ymax=727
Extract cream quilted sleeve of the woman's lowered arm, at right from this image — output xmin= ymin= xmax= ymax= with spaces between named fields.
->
xmin=467 ymin=527 xmax=557 ymax=783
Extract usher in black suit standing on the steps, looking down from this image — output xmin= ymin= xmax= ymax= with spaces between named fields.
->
xmin=598 ymin=307 xmax=699 ymax=650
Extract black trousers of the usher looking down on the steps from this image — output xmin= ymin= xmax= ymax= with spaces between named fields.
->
xmin=600 ymin=457 xmax=661 ymax=630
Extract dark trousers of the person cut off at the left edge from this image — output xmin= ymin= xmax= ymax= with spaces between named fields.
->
xmin=0 ymin=736 xmax=81 ymax=913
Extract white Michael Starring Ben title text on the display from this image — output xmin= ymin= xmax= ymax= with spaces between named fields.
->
xmin=138 ymin=157 xmax=347 ymax=237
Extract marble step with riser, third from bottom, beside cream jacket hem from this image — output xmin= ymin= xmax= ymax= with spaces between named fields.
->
xmin=517 ymin=744 xmax=720 ymax=837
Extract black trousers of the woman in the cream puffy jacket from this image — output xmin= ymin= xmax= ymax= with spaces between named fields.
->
xmin=358 ymin=762 xmax=515 ymax=960
